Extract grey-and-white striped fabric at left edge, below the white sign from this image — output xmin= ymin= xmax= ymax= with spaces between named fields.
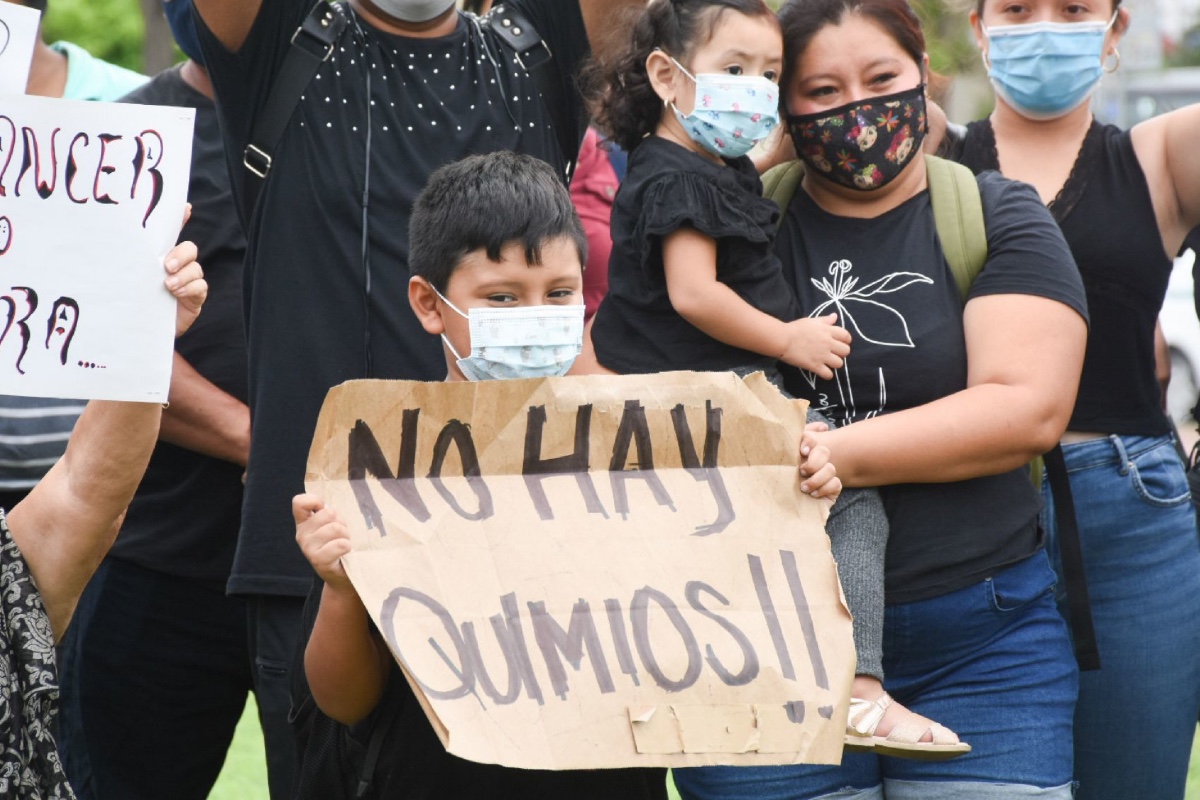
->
xmin=0 ymin=395 xmax=84 ymax=492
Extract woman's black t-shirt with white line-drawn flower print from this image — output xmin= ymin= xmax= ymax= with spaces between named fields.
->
xmin=776 ymin=173 xmax=1086 ymax=603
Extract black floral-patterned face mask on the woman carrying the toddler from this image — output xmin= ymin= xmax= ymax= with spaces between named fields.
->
xmin=787 ymin=84 xmax=926 ymax=192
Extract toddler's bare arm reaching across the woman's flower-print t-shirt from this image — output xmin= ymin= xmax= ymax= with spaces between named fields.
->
xmin=662 ymin=228 xmax=850 ymax=379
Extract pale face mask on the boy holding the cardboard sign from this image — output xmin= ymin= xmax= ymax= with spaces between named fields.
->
xmin=434 ymin=289 xmax=584 ymax=380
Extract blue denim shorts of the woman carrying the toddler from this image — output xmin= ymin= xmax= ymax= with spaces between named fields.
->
xmin=674 ymin=551 xmax=1080 ymax=800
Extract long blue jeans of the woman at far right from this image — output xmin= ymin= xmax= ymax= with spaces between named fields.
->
xmin=1044 ymin=435 xmax=1200 ymax=800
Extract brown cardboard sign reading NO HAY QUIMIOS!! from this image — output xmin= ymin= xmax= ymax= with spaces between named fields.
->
xmin=307 ymin=373 xmax=854 ymax=769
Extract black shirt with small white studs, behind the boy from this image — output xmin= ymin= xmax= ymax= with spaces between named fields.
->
xmin=199 ymin=0 xmax=588 ymax=596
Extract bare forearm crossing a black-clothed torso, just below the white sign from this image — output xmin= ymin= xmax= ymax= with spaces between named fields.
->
xmin=158 ymin=353 xmax=250 ymax=467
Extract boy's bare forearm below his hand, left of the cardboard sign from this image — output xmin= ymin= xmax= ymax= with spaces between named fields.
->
xmin=305 ymin=585 xmax=388 ymax=724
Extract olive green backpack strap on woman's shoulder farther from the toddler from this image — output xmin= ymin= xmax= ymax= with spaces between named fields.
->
xmin=925 ymin=156 xmax=988 ymax=302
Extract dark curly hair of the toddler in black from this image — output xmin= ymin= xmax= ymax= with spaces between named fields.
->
xmin=582 ymin=0 xmax=775 ymax=151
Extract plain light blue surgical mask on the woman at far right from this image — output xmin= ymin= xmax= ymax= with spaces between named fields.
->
xmin=983 ymin=13 xmax=1117 ymax=120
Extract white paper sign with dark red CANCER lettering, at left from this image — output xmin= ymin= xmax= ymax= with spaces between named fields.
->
xmin=0 ymin=94 xmax=196 ymax=402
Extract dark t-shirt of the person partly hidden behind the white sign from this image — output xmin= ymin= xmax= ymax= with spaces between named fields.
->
xmin=109 ymin=67 xmax=246 ymax=585
